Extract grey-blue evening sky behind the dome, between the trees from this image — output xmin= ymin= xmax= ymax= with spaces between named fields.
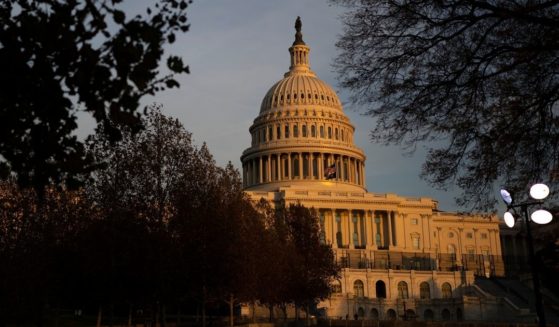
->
xmin=114 ymin=0 xmax=465 ymax=211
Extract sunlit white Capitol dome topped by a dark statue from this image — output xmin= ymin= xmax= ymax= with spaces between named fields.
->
xmin=241 ymin=18 xmax=366 ymax=192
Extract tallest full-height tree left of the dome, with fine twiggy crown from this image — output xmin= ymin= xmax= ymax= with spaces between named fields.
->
xmin=84 ymin=106 xmax=201 ymax=322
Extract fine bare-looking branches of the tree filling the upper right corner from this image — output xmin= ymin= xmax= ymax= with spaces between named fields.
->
xmin=333 ymin=0 xmax=559 ymax=208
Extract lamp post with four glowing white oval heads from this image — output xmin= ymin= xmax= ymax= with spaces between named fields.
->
xmin=501 ymin=183 xmax=553 ymax=327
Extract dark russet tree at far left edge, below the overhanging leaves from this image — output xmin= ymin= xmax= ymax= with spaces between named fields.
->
xmin=0 ymin=180 xmax=93 ymax=325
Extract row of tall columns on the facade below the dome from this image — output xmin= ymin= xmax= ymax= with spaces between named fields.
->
xmin=319 ymin=209 xmax=398 ymax=249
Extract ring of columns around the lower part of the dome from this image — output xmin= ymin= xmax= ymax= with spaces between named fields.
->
xmin=243 ymin=152 xmax=365 ymax=187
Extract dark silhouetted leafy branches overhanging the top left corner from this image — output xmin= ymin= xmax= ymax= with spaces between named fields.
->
xmin=0 ymin=0 xmax=189 ymax=189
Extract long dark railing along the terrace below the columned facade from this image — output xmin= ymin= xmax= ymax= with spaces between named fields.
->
xmin=335 ymin=249 xmax=504 ymax=277
